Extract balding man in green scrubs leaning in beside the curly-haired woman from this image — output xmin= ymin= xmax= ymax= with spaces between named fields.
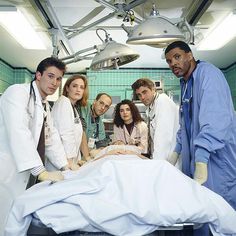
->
xmin=81 ymin=93 xmax=112 ymax=149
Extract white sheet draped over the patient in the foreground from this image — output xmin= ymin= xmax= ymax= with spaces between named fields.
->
xmin=5 ymin=150 xmax=236 ymax=236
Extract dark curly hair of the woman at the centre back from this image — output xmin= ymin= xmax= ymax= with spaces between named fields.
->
xmin=114 ymin=99 xmax=143 ymax=127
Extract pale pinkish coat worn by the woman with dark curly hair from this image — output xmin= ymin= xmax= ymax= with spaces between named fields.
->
xmin=113 ymin=121 xmax=148 ymax=153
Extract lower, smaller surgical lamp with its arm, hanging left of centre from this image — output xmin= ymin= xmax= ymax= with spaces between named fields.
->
xmin=61 ymin=28 xmax=139 ymax=70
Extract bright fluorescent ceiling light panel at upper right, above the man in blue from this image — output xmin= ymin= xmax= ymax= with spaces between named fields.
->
xmin=197 ymin=10 xmax=236 ymax=51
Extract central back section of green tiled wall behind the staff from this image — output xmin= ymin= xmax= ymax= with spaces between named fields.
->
xmin=87 ymin=69 xmax=179 ymax=103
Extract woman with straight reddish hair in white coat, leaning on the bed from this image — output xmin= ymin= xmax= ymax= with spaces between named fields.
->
xmin=52 ymin=75 xmax=89 ymax=169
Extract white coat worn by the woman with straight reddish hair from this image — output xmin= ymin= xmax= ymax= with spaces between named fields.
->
xmin=52 ymin=95 xmax=83 ymax=160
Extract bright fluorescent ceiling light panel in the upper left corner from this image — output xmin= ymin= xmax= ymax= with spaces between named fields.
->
xmin=0 ymin=6 xmax=46 ymax=49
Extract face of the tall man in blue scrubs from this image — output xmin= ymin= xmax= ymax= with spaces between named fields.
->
xmin=165 ymin=48 xmax=196 ymax=80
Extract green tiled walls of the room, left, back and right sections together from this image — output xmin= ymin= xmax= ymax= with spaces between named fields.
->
xmin=0 ymin=59 xmax=236 ymax=109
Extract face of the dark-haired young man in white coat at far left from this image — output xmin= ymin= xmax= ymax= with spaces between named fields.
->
xmin=35 ymin=66 xmax=63 ymax=99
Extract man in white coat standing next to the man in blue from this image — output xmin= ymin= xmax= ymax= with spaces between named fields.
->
xmin=132 ymin=78 xmax=179 ymax=159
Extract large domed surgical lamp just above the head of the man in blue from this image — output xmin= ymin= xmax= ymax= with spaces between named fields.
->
xmin=122 ymin=5 xmax=193 ymax=48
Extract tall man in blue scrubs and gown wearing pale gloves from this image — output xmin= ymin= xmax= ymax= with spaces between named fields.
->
xmin=165 ymin=41 xmax=236 ymax=235
